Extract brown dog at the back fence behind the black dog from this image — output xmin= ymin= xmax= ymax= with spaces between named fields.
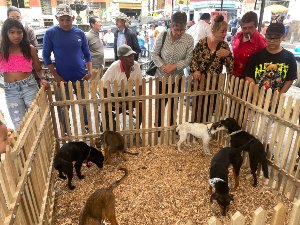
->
xmin=95 ymin=130 xmax=139 ymax=163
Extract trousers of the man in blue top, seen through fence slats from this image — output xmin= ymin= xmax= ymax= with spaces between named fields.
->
xmin=58 ymin=80 xmax=88 ymax=133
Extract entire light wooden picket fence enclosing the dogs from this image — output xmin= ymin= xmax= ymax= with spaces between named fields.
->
xmin=0 ymin=75 xmax=300 ymax=225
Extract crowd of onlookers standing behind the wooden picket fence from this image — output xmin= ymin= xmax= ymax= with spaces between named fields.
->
xmin=0 ymin=4 xmax=297 ymax=139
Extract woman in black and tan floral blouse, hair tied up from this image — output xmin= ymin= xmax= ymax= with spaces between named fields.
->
xmin=190 ymin=15 xmax=233 ymax=122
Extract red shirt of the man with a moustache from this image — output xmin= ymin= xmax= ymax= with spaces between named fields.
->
xmin=232 ymin=30 xmax=267 ymax=78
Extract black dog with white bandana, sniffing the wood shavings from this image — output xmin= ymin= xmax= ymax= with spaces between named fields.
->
xmin=209 ymin=141 xmax=251 ymax=216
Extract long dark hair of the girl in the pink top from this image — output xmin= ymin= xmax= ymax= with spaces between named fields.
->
xmin=0 ymin=18 xmax=31 ymax=61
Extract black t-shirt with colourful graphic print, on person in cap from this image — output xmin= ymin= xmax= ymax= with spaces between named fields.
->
xmin=243 ymin=48 xmax=297 ymax=91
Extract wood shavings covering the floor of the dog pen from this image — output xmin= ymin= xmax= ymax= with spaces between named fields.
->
xmin=53 ymin=141 xmax=292 ymax=225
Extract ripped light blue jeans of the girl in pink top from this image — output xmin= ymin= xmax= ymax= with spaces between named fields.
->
xmin=4 ymin=75 xmax=39 ymax=128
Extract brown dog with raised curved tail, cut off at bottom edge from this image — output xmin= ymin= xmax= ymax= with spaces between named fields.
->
xmin=79 ymin=168 xmax=128 ymax=225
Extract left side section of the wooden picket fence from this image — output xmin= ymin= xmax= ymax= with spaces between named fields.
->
xmin=0 ymin=89 xmax=55 ymax=225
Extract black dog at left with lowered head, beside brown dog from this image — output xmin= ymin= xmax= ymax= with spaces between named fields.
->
xmin=54 ymin=141 xmax=104 ymax=190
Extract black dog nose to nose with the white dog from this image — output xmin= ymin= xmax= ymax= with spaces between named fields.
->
xmin=220 ymin=118 xmax=269 ymax=187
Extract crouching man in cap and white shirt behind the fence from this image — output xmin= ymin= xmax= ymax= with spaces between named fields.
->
xmin=101 ymin=44 xmax=143 ymax=130
